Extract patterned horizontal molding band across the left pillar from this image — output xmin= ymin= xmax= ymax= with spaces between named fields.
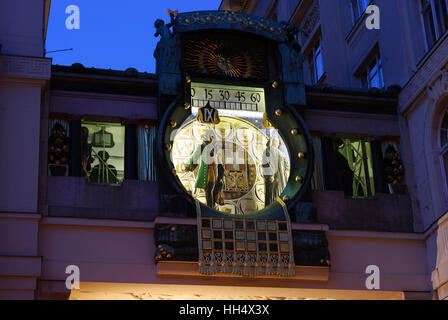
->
xmin=0 ymin=55 xmax=51 ymax=80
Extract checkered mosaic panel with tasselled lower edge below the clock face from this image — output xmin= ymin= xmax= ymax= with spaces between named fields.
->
xmin=198 ymin=200 xmax=295 ymax=276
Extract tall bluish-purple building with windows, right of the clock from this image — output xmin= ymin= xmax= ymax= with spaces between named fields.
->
xmin=221 ymin=0 xmax=448 ymax=298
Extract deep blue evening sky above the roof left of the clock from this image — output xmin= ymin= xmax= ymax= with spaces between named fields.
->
xmin=46 ymin=0 xmax=221 ymax=73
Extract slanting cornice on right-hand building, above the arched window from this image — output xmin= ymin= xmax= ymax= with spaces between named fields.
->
xmin=399 ymin=37 xmax=448 ymax=114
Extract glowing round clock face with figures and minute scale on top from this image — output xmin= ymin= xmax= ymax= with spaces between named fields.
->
xmin=171 ymin=83 xmax=290 ymax=215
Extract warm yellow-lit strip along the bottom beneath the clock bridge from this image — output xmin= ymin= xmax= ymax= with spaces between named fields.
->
xmin=70 ymin=282 xmax=404 ymax=300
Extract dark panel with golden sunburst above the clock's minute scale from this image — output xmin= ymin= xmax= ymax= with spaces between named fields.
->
xmin=184 ymin=34 xmax=266 ymax=79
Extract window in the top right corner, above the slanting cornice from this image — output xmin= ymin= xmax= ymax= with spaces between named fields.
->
xmin=421 ymin=0 xmax=448 ymax=48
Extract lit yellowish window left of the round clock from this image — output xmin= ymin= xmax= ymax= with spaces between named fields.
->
xmin=81 ymin=122 xmax=125 ymax=185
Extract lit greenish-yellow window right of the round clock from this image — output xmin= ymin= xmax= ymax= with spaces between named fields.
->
xmin=333 ymin=139 xmax=375 ymax=198
